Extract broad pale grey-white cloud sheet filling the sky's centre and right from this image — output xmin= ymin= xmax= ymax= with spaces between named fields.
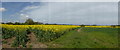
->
xmin=20 ymin=2 xmax=118 ymax=24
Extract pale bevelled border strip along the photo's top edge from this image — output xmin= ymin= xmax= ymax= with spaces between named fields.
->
xmin=1 ymin=0 xmax=119 ymax=2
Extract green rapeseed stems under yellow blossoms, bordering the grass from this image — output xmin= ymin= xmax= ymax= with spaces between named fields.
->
xmin=27 ymin=27 xmax=76 ymax=42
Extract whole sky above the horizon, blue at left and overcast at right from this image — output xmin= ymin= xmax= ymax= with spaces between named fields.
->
xmin=0 ymin=2 xmax=118 ymax=25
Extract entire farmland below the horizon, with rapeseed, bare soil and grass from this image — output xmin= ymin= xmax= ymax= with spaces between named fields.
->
xmin=2 ymin=25 xmax=119 ymax=48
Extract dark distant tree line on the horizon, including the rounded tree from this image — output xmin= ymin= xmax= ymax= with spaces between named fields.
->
xmin=2 ymin=18 xmax=120 ymax=27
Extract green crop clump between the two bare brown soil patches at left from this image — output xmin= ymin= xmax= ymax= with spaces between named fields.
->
xmin=12 ymin=29 xmax=28 ymax=47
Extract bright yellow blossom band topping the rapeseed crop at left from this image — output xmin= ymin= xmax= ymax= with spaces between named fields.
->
xmin=2 ymin=24 xmax=80 ymax=32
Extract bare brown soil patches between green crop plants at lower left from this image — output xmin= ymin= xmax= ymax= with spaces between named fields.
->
xmin=0 ymin=33 xmax=47 ymax=48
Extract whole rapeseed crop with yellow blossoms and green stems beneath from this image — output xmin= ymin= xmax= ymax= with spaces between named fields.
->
xmin=2 ymin=24 xmax=80 ymax=47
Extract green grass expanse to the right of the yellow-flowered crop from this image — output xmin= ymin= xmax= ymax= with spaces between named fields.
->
xmin=47 ymin=28 xmax=118 ymax=48
